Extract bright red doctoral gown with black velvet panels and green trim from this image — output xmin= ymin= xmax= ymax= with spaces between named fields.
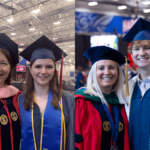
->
xmin=75 ymin=88 xmax=130 ymax=150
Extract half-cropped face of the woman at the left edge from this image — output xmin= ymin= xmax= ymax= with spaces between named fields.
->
xmin=0 ymin=52 xmax=11 ymax=87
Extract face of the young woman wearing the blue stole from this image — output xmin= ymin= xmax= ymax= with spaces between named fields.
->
xmin=29 ymin=59 xmax=55 ymax=86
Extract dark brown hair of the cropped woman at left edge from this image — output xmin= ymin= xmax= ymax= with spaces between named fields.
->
xmin=0 ymin=48 xmax=13 ymax=85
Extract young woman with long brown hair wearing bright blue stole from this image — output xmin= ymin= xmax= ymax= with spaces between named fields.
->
xmin=18 ymin=36 xmax=74 ymax=150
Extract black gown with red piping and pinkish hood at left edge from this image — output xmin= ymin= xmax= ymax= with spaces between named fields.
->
xmin=0 ymin=86 xmax=21 ymax=150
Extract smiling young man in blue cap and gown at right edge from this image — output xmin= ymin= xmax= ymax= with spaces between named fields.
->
xmin=123 ymin=18 xmax=150 ymax=150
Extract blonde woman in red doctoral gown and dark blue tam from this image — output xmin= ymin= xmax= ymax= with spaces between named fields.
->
xmin=75 ymin=46 xmax=130 ymax=150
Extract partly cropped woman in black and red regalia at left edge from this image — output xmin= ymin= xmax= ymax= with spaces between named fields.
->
xmin=0 ymin=33 xmax=21 ymax=150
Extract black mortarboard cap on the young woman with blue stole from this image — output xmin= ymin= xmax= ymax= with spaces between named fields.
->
xmin=20 ymin=35 xmax=67 ymax=62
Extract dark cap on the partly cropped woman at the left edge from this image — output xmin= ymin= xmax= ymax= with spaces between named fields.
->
xmin=0 ymin=33 xmax=19 ymax=66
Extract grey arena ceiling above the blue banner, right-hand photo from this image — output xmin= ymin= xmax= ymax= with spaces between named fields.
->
xmin=76 ymin=0 xmax=150 ymax=18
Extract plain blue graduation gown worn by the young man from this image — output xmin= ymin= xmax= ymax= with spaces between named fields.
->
xmin=129 ymin=82 xmax=150 ymax=150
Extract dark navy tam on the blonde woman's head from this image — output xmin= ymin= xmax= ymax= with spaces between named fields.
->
xmin=84 ymin=46 xmax=126 ymax=65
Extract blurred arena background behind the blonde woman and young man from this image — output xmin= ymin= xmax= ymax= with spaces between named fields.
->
xmin=75 ymin=0 xmax=150 ymax=89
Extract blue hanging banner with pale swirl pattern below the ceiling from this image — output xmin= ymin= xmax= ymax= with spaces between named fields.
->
xmin=75 ymin=12 xmax=138 ymax=34
